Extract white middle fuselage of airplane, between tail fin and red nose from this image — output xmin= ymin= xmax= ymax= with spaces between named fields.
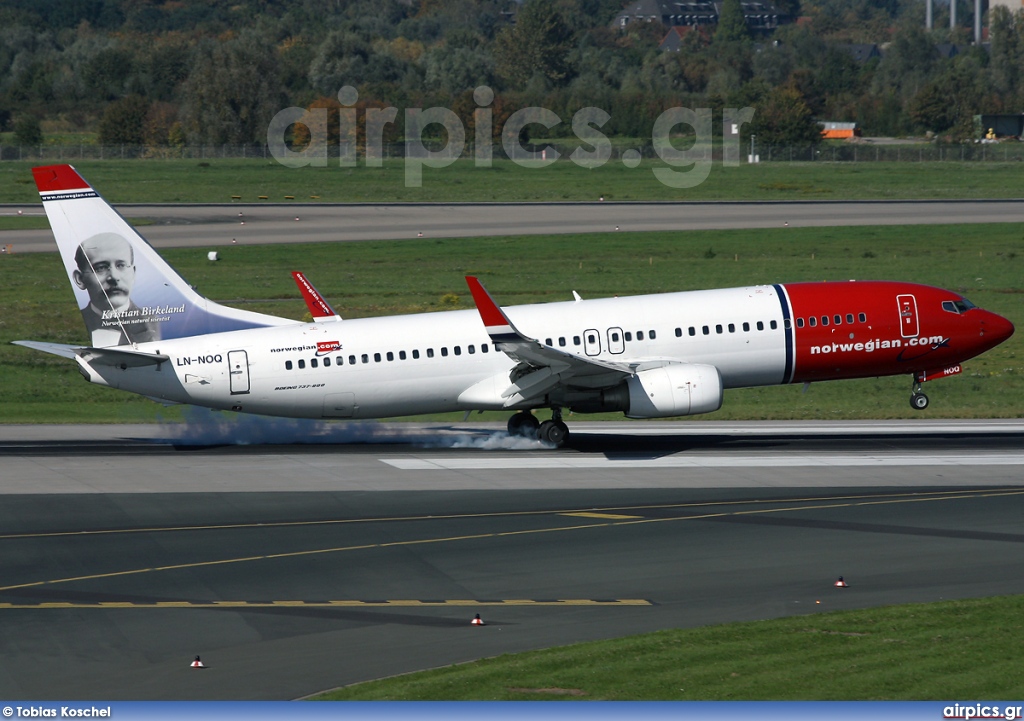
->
xmin=92 ymin=286 xmax=786 ymax=418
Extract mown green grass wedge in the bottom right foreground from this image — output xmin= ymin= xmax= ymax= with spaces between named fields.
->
xmin=315 ymin=596 xmax=1024 ymax=701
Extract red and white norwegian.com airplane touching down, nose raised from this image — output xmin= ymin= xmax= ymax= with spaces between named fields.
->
xmin=15 ymin=165 xmax=1014 ymax=447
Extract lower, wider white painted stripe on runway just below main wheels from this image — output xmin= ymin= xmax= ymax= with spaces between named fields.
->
xmin=380 ymin=453 xmax=1024 ymax=471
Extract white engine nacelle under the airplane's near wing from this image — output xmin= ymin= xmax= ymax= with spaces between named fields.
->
xmin=626 ymin=364 xmax=722 ymax=418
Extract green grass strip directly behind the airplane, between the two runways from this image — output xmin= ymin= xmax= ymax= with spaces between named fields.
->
xmin=0 ymin=224 xmax=1024 ymax=423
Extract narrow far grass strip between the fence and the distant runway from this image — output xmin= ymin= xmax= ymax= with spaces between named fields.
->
xmin=0 ymin=159 xmax=1024 ymax=203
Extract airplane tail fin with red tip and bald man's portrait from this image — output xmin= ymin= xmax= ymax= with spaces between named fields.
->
xmin=32 ymin=165 xmax=295 ymax=348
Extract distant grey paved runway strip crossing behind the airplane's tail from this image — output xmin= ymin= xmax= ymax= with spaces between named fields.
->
xmin=0 ymin=200 xmax=1024 ymax=253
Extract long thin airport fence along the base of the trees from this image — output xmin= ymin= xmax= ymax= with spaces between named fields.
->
xmin=0 ymin=140 xmax=1024 ymax=163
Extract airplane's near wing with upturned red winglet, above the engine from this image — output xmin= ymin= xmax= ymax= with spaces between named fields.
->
xmin=466 ymin=275 xmax=637 ymax=405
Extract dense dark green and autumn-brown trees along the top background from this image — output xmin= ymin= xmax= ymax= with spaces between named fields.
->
xmin=0 ymin=0 xmax=1024 ymax=146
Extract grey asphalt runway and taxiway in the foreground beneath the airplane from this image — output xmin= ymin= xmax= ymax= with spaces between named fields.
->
xmin=0 ymin=418 xmax=1024 ymax=699
